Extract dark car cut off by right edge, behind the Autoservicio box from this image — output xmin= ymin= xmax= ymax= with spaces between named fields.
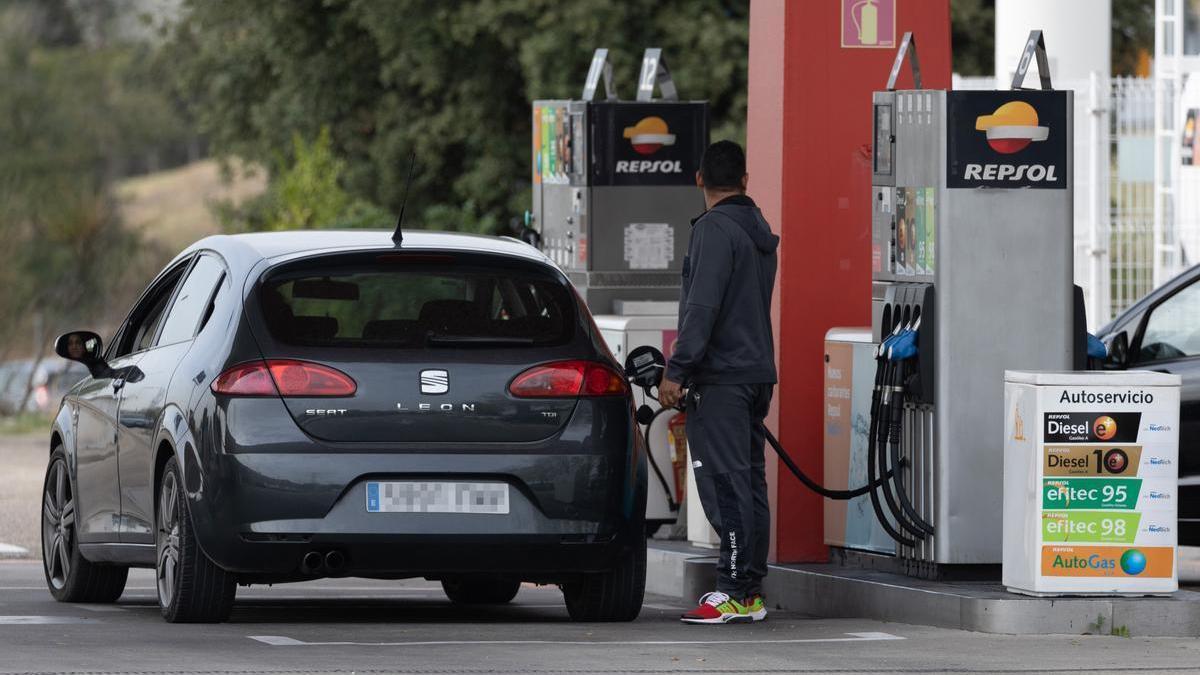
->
xmin=1097 ymin=265 xmax=1200 ymax=546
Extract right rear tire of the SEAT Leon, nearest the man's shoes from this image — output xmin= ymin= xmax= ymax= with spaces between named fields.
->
xmin=563 ymin=532 xmax=646 ymax=621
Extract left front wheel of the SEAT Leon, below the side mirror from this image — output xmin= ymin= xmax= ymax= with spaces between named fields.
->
xmin=42 ymin=446 xmax=130 ymax=603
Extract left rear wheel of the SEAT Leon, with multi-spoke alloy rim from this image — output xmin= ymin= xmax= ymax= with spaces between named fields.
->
xmin=155 ymin=458 xmax=238 ymax=623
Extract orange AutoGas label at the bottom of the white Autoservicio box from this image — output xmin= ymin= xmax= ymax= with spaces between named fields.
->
xmin=1042 ymin=545 xmax=1175 ymax=578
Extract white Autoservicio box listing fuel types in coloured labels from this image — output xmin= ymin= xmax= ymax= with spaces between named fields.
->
xmin=1003 ymin=371 xmax=1180 ymax=596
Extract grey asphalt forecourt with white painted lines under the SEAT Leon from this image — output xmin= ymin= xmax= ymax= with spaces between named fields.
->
xmin=0 ymin=561 xmax=1200 ymax=674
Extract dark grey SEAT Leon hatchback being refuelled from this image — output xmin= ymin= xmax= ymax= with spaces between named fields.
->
xmin=43 ymin=231 xmax=646 ymax=621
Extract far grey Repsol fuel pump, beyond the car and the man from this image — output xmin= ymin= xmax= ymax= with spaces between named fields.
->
xmin=528 ymin=48 xmax=708 ymax=315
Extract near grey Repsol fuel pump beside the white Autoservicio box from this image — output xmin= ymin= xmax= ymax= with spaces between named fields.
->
xmin=844 ymin=31 xmax=1086 ymax=575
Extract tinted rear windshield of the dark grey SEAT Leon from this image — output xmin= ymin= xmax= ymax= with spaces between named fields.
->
xmin=260 ymin=256 xmax=576 ymax=348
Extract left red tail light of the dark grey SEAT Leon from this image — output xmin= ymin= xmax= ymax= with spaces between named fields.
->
xmin=212 ymin=359 xmax=358 ymax=398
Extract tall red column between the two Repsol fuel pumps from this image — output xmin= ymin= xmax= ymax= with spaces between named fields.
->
xmin=746 ymin=0 xmax=950 ymax=562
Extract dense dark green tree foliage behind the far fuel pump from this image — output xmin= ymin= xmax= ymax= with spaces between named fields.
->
xmin=164 ymin=0 xmax=749 ymax=231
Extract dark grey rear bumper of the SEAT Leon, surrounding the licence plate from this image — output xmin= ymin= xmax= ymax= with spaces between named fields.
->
xmin=184 ymin=400 xmax=646 ymax=581
